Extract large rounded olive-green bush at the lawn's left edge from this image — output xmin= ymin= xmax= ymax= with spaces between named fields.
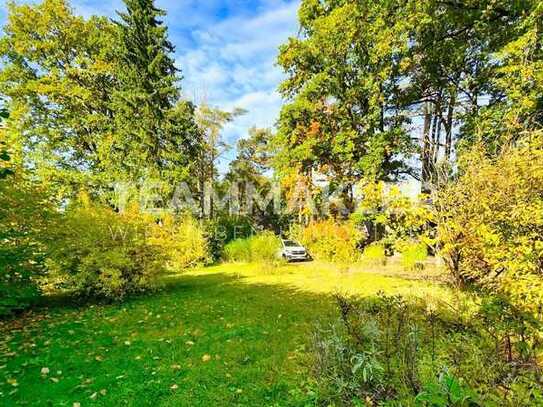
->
xmin=47 ymin=197 xmax=168 ymax=299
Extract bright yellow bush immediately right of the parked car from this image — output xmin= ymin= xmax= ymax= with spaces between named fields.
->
xmin=291 ymin=220 xmax=365 ymax=263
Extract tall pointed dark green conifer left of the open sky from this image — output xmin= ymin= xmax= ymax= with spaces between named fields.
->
xmin=112 ymin=0 xmax=196 ymax=180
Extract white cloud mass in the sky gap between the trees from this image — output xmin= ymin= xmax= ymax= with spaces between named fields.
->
xmin=177 ymin=0 xmax=298 ymax=155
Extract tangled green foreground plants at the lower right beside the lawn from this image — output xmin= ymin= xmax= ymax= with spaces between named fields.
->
xmin=310 ymin=295 xmax=543 ymax=407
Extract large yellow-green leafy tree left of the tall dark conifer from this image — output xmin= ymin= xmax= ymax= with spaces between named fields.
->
xmin=0 ymin=0 xmax=116 ymax=196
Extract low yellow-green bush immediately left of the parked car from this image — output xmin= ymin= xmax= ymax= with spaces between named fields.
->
xmin=224 ymin=232 xmax=281 ymax=263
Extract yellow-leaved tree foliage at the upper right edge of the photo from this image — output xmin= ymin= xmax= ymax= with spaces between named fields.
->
xmin=463 ymin=1 xmax=543 ymax=155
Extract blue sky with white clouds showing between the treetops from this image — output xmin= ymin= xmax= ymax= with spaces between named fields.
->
xmin=0 ymin=0 xmax=299 ymax=170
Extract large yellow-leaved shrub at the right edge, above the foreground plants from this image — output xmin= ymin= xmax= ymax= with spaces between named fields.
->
xmin=437 ymin=135 xmax=543 ymax=313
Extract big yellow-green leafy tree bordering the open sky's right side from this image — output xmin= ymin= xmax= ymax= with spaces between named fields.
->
xmin=275 ymin=1 xmax=413 ymax=202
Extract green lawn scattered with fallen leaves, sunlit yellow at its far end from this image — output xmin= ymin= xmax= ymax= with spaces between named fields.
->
xmin=0 ymin=263 xmax=451 ymax=406
